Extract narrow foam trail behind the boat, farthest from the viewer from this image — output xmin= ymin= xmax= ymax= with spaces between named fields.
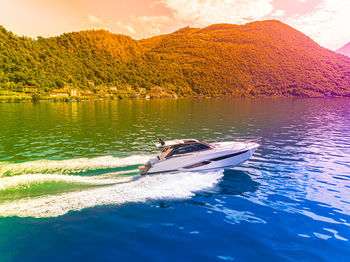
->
xmin=0 ymin=155 xmax=150 ymax=177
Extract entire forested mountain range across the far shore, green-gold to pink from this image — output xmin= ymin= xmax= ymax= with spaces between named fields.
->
xmin=0 ymin=21 xmax=350 ymax=97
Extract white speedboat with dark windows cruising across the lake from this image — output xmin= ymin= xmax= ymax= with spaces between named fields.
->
xmin=139 ymin=139 xmax=259 ymax=175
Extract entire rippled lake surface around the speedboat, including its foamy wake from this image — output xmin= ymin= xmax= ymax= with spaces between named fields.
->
xmin=0 ymin=99 xmax=350 ymax=261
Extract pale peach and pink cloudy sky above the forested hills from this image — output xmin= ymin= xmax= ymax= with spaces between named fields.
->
xmin=0 ymin=0 xmax=350 ymax=50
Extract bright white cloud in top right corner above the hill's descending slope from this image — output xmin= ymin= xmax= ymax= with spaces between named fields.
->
xmin=286 ymin=0 xmax=350 ymax=50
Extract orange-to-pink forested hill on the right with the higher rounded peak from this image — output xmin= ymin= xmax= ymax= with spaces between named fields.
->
xmin=141 ymin=21 xmax=350 ymax=96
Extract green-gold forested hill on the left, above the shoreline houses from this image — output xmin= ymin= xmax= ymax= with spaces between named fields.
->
xmin=0 ymin=28 xmax=191 ymax=94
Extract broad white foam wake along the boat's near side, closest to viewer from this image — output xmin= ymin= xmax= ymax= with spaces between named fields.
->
xmin=0 ymin=171 xmax=223 ymax=218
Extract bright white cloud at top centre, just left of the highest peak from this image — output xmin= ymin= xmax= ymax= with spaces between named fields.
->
xmin=162 ymin=0 xmax=274 ymax=27
